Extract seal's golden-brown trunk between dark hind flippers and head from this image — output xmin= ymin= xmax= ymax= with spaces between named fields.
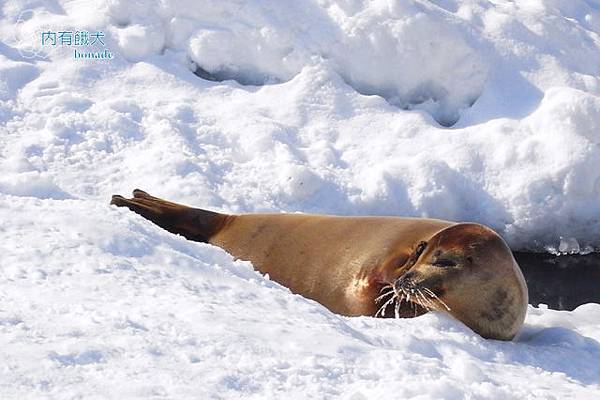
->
xmin=209 ymin=214 xmax=449 ymax=316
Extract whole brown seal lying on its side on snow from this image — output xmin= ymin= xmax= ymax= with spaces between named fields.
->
xmin=111 ymin=189 xmax=528 ymax=340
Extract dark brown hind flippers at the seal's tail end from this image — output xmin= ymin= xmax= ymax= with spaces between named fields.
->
xmin=110 ymin=189 xmax=228 ymax=242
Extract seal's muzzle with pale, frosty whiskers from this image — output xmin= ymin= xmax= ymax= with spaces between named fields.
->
xmin=375 ymin=274 xmax=450 ymax=318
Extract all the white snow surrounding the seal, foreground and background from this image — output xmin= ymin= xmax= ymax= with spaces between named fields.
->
xmin=0 ymin=0 xmax=600 ymax=400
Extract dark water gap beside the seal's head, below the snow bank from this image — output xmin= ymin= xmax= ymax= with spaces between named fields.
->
xmin=514 ymin=252 xmax=600 ymax=310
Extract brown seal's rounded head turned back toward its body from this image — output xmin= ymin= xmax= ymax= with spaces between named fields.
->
xmin=394 ymin=223 xmax=528 ymax=340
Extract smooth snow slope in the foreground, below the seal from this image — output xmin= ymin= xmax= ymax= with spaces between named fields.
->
xmin=0 ymin=195 xmax=600 ymax=399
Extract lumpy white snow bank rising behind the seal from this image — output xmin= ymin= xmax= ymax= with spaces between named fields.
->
xmin=0 ymin=0 xmax=600 ymax=251
